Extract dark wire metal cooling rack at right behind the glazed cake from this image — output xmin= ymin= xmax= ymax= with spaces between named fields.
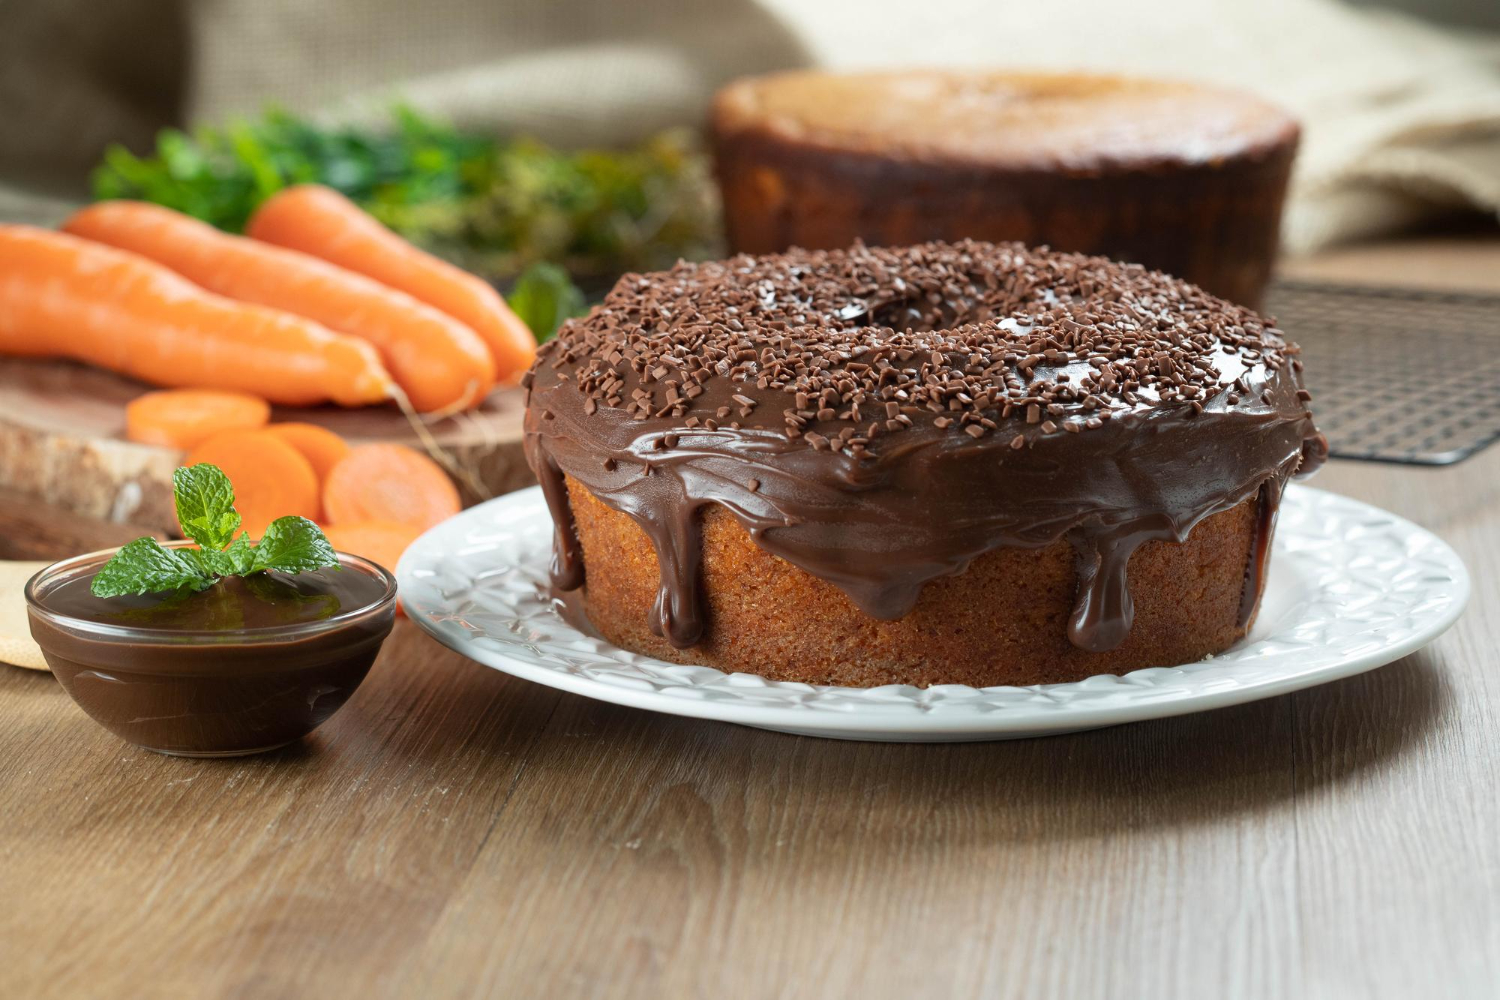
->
xmin=1266 ymin=280 xmax=1500 ymax=465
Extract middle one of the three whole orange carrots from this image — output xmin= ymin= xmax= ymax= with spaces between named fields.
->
xmin=63 ymin=201 xmax=495 ymax=412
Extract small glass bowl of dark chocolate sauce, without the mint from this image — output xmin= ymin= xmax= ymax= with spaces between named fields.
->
xmin=29 ymin=553 xmax=395 ymax=756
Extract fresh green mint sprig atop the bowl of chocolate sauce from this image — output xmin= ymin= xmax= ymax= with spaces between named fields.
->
xmin=90 ymin=463 xmax=339 ymax=597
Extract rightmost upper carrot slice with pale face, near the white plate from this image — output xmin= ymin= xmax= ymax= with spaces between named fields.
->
xmin=323 ymin=444 xmax=459 ymax=529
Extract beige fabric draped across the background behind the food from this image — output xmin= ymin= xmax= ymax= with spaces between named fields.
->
xmin=0 ymin=0 xmax=1500 ymax=249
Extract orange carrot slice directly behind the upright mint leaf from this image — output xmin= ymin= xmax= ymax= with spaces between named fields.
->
xmin=186 ymin=430 xmax=318 ymax=538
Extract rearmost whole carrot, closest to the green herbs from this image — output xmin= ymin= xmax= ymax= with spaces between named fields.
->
xmin=246 ymin=184 xmax=537 ymax=378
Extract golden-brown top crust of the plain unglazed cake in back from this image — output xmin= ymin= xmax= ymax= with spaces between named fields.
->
xmin=714 ymin=70 xmax=1298 ymax=174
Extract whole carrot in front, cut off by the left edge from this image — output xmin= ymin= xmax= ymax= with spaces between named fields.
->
xmin=0 ymin=225 xmax=393 ymax=406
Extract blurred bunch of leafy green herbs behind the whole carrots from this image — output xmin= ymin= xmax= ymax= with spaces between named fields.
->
xmin=93 ymin=108 xmax=719 ymax=296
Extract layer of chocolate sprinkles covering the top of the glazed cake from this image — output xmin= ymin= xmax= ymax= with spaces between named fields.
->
xmin=539 ymin=243 xmax=1289 ymax=456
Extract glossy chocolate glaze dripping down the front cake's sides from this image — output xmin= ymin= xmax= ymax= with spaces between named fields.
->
xmin=525 ymin=244 xmax=1325 ymax=651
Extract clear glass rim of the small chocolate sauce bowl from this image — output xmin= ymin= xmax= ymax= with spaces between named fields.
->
xmin=23 ymin=540 xmax=396 ymax=645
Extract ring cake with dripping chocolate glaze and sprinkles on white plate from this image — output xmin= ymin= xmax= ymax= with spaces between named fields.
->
xmin=525 ymin=243 xmax=1326 ymax=685
